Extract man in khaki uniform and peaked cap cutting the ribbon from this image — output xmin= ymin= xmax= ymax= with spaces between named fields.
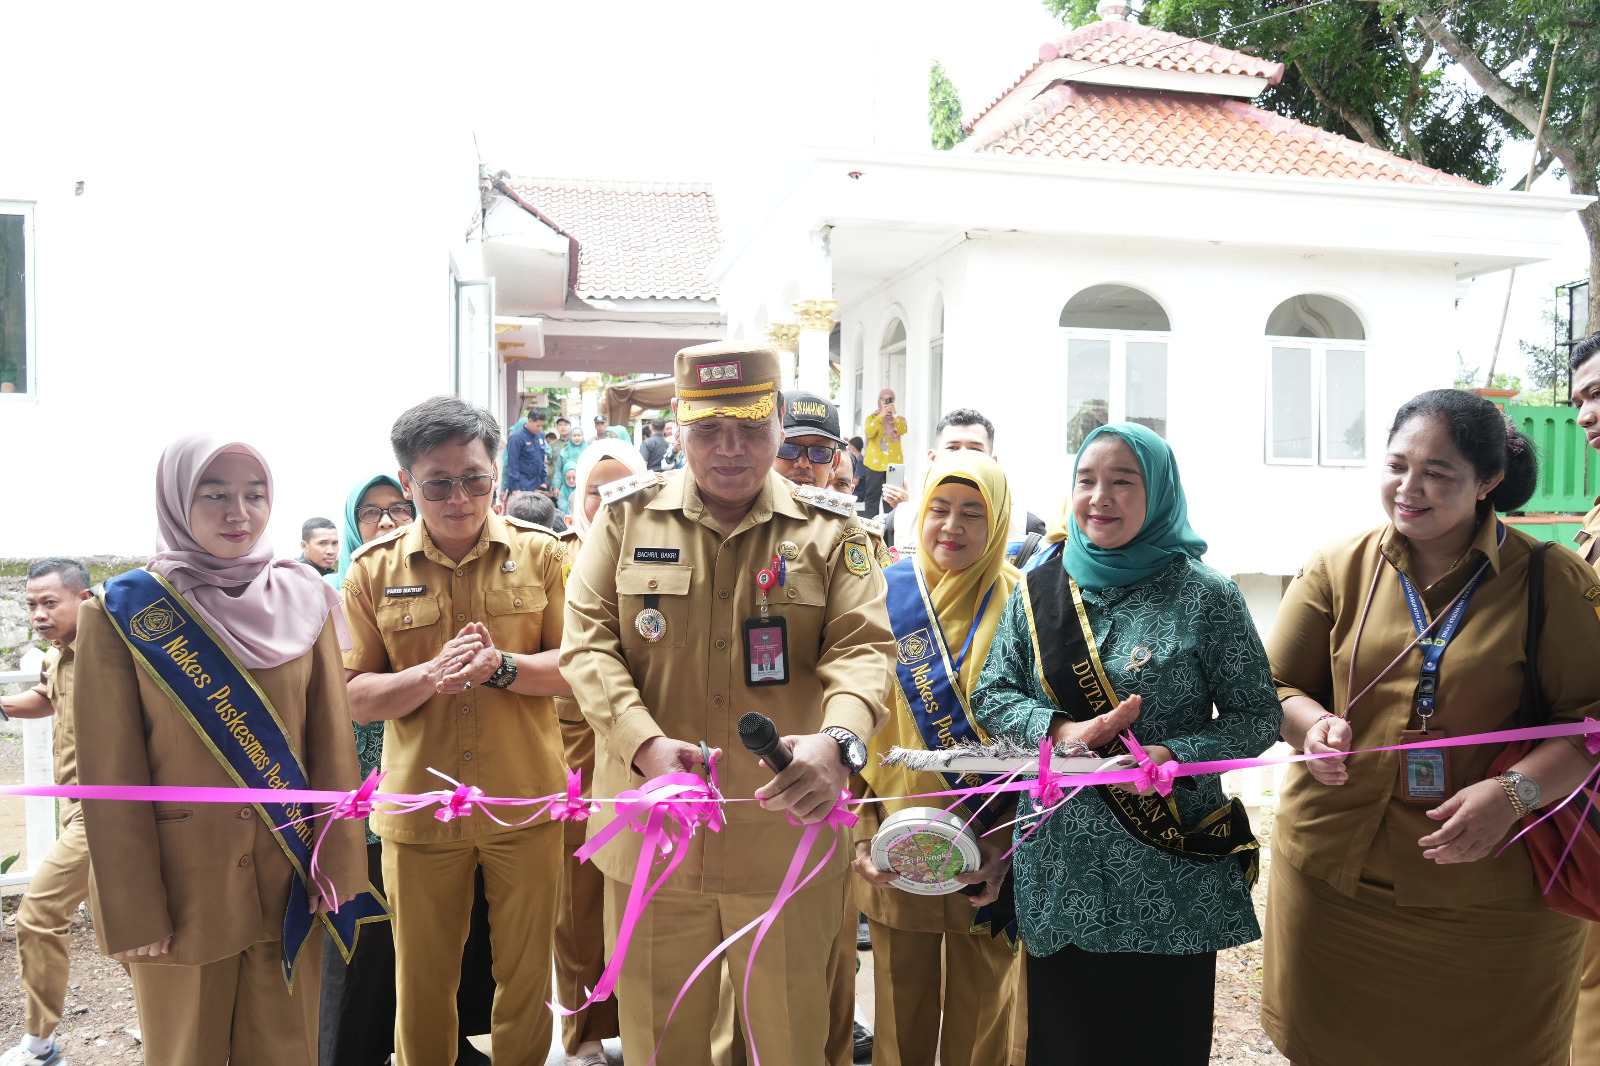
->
xmin=562 ymin=344 xmax=893 ymax=1066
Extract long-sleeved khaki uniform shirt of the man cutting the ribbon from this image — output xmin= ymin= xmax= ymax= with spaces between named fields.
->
xmin=562 ymin=471 xmax=894 ymax=893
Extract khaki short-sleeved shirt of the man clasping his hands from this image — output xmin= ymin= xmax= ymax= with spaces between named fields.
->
xmin=344 ymin=514 xmax=566 ymax=844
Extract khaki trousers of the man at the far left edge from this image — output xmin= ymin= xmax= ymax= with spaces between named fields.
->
xmin=16 ymin=804 xmax=90 ymax=1037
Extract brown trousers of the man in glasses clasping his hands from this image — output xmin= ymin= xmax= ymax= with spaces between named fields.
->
xmin=387 ymin=823 xmax=562 ymax=1066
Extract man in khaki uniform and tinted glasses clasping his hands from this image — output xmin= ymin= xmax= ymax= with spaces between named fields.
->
xmin=344 ymin=397 xmax=570 ymax=1066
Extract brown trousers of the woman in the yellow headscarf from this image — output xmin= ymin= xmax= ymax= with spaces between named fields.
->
xmin=869 ymin=919 xmax=1018 ymax=1066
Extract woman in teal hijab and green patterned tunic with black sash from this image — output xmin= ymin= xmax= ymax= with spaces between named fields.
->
xmin=973 ymin=423 xmax=1283 ymax=1066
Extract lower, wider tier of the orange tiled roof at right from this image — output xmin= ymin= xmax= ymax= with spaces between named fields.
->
xmin=960 ymin=85 xmax=1474 ymax=187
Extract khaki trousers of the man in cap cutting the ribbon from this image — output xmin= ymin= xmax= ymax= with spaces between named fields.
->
xmin=605 ymin=877 xmax=843 ymax=1066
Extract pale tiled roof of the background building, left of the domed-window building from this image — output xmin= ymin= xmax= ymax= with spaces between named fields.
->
xmin=504 ymin=178 xmax=723 ymax=301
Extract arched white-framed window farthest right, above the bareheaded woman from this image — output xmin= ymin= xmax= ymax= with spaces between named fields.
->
xmin=1266 ymin=293 xmax=1366 ymax=466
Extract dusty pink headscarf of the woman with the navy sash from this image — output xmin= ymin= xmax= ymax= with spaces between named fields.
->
xmin=146 ymin=434 xmax=350 ymax=671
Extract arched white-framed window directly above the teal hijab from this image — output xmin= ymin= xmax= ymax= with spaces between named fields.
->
xmin=1061 ymin=285 xmax=1171 ymax=455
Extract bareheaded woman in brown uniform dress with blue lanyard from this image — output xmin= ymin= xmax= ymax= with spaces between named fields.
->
xmin=1261 ymin=391 xmax=1600 ymax=1066
